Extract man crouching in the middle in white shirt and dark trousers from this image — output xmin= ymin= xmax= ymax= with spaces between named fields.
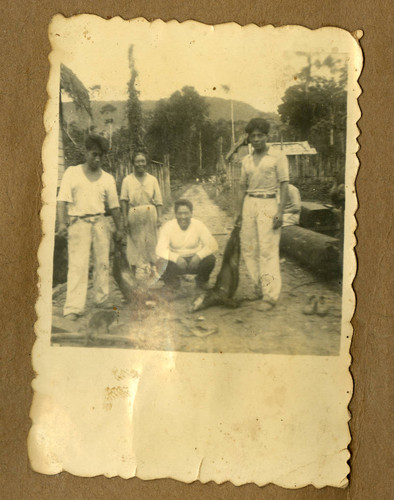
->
xmin=156 ymin=199 xmax=218 ymax=289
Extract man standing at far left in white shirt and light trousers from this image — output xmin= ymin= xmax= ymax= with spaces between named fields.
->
xmin=58 ymin=134 xmax=122 ymax=320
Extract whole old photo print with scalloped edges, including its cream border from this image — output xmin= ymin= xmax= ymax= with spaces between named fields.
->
xmin=28 ymin=15 xmax=362 ymax=488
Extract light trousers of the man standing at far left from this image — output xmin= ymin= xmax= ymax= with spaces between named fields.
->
xmin=63 ymin=215 xmax=110 ymax=315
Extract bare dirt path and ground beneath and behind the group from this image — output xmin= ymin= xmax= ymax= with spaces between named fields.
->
xmin=53 ymin=185 xmax=341 ymax=355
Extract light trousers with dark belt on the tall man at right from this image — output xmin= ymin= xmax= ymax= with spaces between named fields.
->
xmin=241 ymin=195 xmax=282 ymax=303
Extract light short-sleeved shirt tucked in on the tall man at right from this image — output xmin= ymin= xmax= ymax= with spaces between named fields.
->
xmin=240 ymin=149 xmax=289 ymax=194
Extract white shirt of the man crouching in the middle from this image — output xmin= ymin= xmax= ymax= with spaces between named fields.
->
xmin=156 ymin=219 xmax=218 ymax=262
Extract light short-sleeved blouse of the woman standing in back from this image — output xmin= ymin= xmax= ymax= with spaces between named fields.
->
xmin=120 ymin=173 xmax=163 ymax=207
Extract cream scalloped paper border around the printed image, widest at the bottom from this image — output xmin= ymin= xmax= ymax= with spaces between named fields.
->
xmin=29 ymin=18 xmax=362 ymax=488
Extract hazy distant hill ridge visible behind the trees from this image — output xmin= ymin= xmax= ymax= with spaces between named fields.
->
xmin=64 ymin=97 xmax=280 ymax=131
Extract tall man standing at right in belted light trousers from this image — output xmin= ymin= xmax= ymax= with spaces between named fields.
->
xmin=238 ymin=118 xmax=289 ymax=310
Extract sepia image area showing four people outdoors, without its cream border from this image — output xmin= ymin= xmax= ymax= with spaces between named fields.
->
xmin=51 ymin=21 xmax=349 ymax=356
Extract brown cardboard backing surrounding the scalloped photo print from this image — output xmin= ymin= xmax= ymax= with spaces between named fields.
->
xmin=0 ymin=0 xmax=393 ymax=500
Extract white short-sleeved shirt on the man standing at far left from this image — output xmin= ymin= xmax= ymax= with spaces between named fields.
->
xmin=57 ymin=165 xmax=119 ymax=217
